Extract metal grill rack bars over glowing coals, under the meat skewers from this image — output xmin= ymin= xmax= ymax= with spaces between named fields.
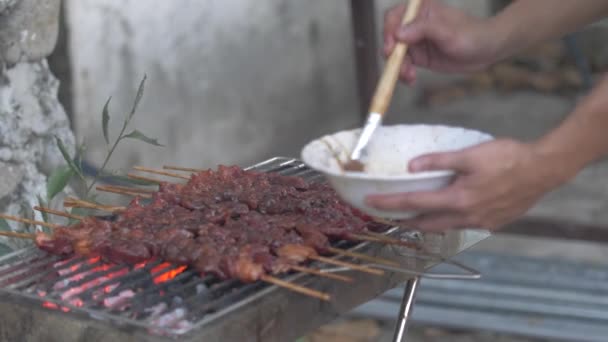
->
xmin=0 ymin=157 xmax=486 ymax=337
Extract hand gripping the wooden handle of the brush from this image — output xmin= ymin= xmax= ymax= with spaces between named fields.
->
xmin=384 ymin=0 xmax=497 ymax=84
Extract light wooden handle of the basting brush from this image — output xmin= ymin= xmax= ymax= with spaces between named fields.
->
xmin=369 ymin=0 xmax=422 ymax=116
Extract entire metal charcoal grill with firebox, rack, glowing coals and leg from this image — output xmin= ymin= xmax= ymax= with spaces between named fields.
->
xmin=0 ymin=158 xmax=488 ymax=342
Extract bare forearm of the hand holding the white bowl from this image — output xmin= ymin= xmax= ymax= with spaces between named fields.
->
xmin=535 ymin=77 xmax=608 ymax=183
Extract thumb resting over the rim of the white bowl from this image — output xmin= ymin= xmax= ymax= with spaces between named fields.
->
xmin=409 ymin=152 xmax=472 ymax=172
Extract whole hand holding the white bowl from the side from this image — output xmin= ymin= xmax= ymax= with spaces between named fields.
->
xmin=368 ymin=140 xmax=566 ymax=232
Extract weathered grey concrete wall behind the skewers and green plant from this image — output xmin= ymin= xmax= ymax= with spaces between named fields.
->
xmin=68 ymin=0 xmax=485 ymax=171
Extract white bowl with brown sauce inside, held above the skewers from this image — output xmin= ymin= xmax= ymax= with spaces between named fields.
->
xmin=302 ymin=125 xmax=493 ymax=219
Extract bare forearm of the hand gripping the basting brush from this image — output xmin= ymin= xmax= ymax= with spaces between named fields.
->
xmin=489 ymin=0 xmax=608 ymax=60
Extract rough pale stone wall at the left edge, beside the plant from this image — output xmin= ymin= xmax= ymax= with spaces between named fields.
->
xmin=0 ymin=0 xmax=74 ymax=247
